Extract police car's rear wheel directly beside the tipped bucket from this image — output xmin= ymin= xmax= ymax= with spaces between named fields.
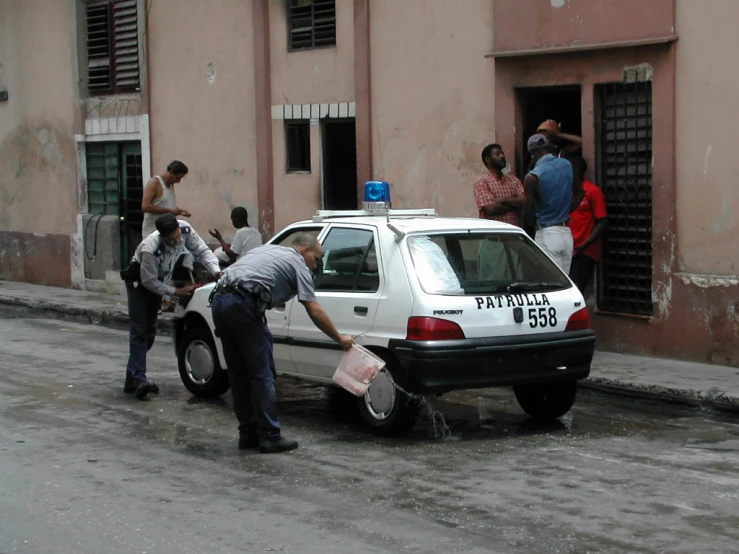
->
xmin=357 ymin=361 xmax=421 ymax=437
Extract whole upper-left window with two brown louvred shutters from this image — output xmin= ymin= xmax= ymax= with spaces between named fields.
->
xmin=85 ymin=0 xmax=139 ymax=95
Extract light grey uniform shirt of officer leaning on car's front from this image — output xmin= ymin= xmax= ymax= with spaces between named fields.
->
xmin=133 ymin=220 xmax=221 ymax=296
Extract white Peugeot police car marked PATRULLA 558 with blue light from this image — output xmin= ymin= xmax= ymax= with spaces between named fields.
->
xmin=175 ymin=181 xmax=595 ymax=435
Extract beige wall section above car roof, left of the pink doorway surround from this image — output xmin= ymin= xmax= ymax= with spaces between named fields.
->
xmin=370 ymin=0 xmax=498 ymax=217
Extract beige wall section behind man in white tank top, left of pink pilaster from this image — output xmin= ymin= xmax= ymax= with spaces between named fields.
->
xmin=146 ymin=0 xmax=259 ymax=242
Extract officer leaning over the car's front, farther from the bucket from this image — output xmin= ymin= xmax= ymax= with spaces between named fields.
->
xmin=121 ymin=214 xmax=222 ymax=400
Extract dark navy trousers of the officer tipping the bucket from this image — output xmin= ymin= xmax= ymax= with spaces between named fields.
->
xmin=211 ymin=293 xmax=280 ymax=439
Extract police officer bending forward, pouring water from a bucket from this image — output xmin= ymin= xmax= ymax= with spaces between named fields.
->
xmin=211 ymin=233 xmax=354 ymax=453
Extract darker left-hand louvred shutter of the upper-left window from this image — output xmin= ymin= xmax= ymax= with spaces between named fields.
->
xmin=85 ymin=4 xmax=113 ymax=92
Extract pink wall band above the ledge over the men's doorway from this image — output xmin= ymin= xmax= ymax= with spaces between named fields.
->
xmin=493 ymin=0 xmax=672 ymax=51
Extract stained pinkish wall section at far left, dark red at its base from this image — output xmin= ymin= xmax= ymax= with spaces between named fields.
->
xmin=0 ymin=0 xmax=77 ymax=286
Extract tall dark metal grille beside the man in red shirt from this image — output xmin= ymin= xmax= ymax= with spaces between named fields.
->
xmin=596 ymin=82 xmax=653 ymax=316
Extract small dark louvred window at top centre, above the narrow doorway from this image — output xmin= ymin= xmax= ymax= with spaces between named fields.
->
xmin=287 ymin=0 xmax=336 ymax=50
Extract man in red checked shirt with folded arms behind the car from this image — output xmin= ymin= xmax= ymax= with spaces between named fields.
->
xmin=473 ymin=144 xmax=523 ymax=280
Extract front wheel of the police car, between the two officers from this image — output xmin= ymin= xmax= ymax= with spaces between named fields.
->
xmin=177 ymin=327 xmax=229 ymax=398
